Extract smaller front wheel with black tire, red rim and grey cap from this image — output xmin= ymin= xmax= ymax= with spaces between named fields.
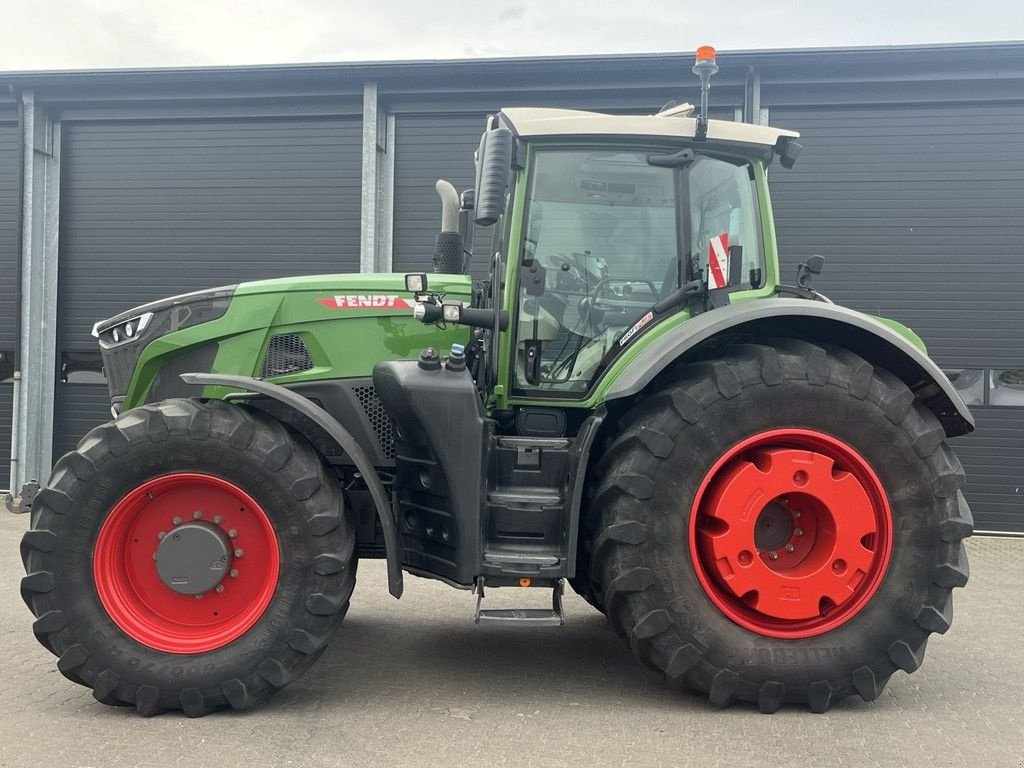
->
xmin=22 ymin=399 xmax=355 ymax=717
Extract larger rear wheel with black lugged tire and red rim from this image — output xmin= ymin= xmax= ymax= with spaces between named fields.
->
xmin=589 ymin=340 xmax=972 ymax=713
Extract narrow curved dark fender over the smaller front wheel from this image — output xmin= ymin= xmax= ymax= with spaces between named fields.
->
xmin=181 ymin=374 xmax=402 ymax=597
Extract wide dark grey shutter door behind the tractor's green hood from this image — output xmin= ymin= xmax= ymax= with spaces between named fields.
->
xmin=54 ymin=118 xmax=361 ymax=460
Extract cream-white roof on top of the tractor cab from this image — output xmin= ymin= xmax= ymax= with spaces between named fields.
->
xmin=501 ymin=104 xmax=800 ymax=148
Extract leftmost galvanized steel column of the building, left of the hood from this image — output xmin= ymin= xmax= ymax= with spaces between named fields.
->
xmin=10 ymin=91 xmax=60 ymax=494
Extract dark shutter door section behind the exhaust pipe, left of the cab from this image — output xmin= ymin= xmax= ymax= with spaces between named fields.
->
xmin=392 ymin=113 xmax=494 ymax=276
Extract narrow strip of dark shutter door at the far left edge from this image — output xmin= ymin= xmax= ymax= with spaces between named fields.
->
xmin=0 ymin=111 xmax=22 ymax=489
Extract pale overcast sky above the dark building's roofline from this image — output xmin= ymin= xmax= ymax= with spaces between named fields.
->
xmin=0 ymin=0 xmax=1024 ymax=71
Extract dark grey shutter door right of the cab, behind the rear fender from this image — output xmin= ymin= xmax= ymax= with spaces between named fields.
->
xmin=771 ymin=103 xmax=1024 ymax=530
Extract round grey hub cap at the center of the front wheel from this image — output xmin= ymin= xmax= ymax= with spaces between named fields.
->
xmin=155 ymin=522 xmax=231 ymax=595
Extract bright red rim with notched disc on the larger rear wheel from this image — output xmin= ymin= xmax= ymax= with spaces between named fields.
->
xmin=689 ymin=429 xmax=892 ymax=639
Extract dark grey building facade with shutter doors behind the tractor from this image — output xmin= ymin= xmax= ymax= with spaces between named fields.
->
xmin=0 ymin=45 xmax=1024 ymax=530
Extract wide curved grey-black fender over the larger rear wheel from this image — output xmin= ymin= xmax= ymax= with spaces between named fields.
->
xmin=605 ymin=298 xmax=974 ymax=437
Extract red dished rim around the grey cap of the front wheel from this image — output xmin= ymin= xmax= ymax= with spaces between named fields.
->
xmin=92 ymin=473 xmax=281 ymax=653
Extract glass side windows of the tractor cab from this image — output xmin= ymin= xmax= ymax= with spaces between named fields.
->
xmin=515 ymin=150 xmax=762 ymax=395
